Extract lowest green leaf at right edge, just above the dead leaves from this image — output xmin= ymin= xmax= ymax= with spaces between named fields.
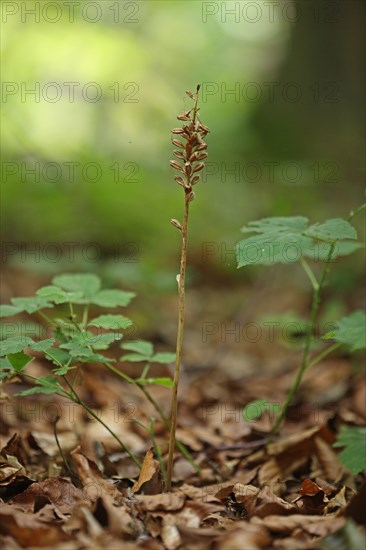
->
xmin=333 ymin=425 xmax=366 ymax=474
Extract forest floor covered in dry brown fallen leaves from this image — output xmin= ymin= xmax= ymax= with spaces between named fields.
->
xmin=0 ymin=270 xmax=366 ymax=550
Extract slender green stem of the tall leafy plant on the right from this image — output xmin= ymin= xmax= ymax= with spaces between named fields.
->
xmin=271 ymin=243 xmax=335 ymax=435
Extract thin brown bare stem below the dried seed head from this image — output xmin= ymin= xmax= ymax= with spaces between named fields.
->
xmin=166 ymin=193 xmax=189 ymax=491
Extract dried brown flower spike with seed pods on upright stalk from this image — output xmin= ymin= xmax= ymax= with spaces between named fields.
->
xmin=166 ymin=85 xmax=209 ymax=491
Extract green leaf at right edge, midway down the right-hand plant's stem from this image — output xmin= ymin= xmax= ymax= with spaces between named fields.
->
xmin=323 ymin=310 xmax=366 ymax=351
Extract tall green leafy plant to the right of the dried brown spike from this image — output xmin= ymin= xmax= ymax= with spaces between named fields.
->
xmin=236 ymin=205 xmax=366 ymax=435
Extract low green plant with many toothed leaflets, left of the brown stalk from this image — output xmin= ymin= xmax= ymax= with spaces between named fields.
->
xmin=0 ymin=274 xmax=182 ymax=466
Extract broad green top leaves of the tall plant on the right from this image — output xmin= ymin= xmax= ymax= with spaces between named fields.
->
xmin=236 ymin=216 xmax=362 ymax=268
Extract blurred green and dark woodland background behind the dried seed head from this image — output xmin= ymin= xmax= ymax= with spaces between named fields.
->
xmin=1 ymin=0 xmax=365 ymax=298
